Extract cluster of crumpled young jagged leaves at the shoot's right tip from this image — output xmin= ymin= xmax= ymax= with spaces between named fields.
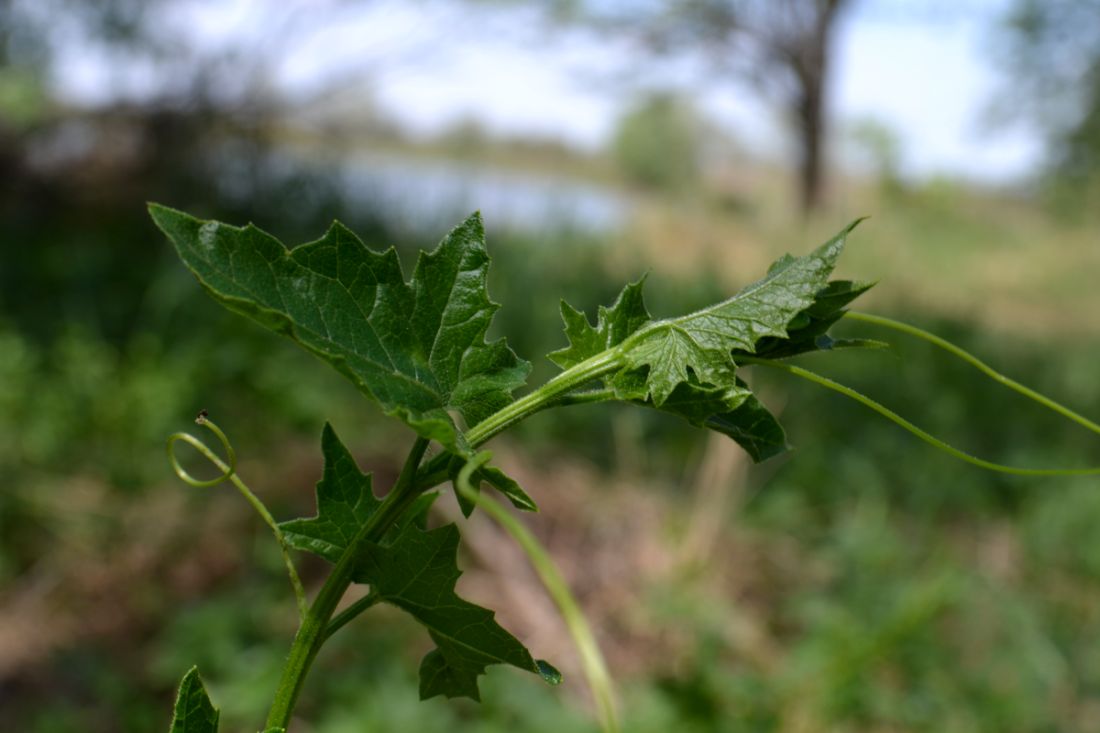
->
xmin=550 ymin=221 xmax=873 ymax=461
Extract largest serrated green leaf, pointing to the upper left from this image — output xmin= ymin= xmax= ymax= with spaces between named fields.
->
xmin=150 ymin=205 xmax=530 ymax=452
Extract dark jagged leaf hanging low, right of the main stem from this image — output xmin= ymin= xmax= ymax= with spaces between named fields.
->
xmin=354 ymin=524 xmax=552 ymax=700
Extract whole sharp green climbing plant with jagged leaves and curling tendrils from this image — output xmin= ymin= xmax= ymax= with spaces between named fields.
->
xmin=150 ymin=201 xmax=1100 ymax=733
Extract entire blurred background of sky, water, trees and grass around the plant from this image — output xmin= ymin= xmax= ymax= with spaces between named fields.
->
xmin=0 ymin=0 xmax=1100 ymax=733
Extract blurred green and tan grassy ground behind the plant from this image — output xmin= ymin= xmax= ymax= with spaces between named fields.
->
xmin=0 ymin=144 xmax=1100 ymax=733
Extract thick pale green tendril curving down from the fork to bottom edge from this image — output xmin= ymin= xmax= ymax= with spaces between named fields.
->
xmin=455 ymin=451 xmax=619 ymax=733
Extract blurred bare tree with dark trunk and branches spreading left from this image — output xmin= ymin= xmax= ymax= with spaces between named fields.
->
xmin=558 ymin=0 xmax=848 ymax=212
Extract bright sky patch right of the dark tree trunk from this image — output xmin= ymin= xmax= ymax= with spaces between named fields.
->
xmin=834 ymin=0 xmax=1043 ymax=179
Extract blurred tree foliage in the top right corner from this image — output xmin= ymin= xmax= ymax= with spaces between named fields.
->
xmin=1000 ymin=0 xmax=1100 ymax=184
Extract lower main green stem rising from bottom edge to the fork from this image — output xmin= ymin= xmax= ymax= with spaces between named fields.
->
xmin=266 ymin=437 xmax=428 ymax=729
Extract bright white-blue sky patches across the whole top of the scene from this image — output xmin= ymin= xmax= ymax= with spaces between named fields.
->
xmin=63 ymin=0 xmax=1042 ymax=182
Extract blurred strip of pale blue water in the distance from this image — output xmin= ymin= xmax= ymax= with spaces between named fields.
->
xmin=341 ymin=154 xmax=630 ymax=233
